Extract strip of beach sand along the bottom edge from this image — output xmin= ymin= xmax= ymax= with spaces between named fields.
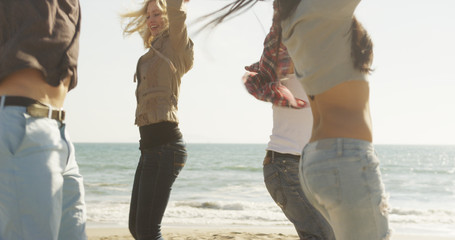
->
xmin=87 ymin=226 xmax=455 ymax=240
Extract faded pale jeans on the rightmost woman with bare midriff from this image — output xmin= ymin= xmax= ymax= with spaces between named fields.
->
xmin=299 ymin=138 xmax=390 ymax=240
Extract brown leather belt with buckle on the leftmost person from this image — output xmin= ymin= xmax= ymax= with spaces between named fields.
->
xmin=2 ymin=96 xmax=65 ymax=122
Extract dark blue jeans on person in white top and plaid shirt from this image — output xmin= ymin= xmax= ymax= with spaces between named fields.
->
xmin=263 ymin=153 xmax=335 ymax=240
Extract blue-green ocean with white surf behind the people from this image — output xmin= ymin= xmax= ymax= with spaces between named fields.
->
xmin=75 ymin=143 xmax=455 ymax=237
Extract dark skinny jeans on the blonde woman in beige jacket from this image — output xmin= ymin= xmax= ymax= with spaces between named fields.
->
xmin=129 ymin=140 xmax=187 ymax=240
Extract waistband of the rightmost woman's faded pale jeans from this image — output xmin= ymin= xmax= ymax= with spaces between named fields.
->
xmin=304 ymin=138 xmax=374 ymax=152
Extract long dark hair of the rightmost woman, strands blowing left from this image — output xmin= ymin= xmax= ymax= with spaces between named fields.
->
xmin=202 ymin=0 xmax=373 ymax=73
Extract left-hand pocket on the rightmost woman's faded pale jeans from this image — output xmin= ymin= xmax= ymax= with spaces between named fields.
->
xmin=305 ymin=168 xmax=342 ymax=209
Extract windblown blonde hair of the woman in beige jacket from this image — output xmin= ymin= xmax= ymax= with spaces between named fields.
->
xmin=120 ymin=0 xmax=169 ymax=48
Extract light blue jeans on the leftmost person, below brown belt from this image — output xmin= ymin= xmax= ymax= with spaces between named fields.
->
xmin=0 ymin=106 xmax=87 ymax=240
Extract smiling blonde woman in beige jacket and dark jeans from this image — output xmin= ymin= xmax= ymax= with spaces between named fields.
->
xmin=123 ymin=0 xmax=193 ymax=240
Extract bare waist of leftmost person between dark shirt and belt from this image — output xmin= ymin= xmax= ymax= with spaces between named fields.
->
xmin=0 ymin=69 xmax=71 ymax=108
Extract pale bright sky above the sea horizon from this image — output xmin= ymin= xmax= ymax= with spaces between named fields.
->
xmin=64 ymin=0 xmax=455 ymax=145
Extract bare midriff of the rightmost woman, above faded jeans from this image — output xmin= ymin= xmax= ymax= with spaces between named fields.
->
xmin=310 ymin=81 xmax=373 ymax=142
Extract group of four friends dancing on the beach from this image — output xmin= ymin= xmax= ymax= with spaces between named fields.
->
xmin=0 ymin=0 xmax=390 ymax=240
